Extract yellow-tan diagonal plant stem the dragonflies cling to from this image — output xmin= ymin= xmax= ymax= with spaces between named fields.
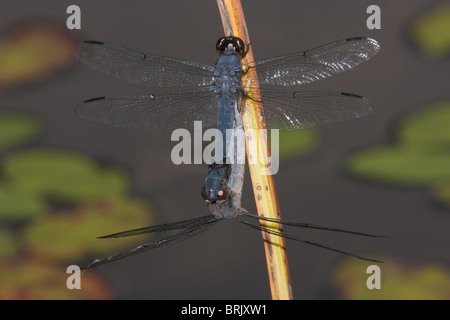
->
xmin=217 ymin=0 xmax=293 ymax=300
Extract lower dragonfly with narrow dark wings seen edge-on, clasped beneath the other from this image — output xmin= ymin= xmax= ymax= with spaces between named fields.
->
xmin=82 ymin=100 xmax=383 ymax=269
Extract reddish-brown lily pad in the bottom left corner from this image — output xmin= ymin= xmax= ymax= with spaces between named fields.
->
xmin=0 ymin=259 xmax=113 ymax=300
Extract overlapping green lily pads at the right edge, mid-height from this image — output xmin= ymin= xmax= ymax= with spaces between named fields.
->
xmin=345 ymin=101 xmax=450 ymax=187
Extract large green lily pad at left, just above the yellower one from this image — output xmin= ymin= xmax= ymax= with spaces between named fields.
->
xmin=3 ymin=149 xmax=128 ymax=203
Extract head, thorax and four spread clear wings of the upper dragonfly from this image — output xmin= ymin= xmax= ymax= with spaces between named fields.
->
xmin=75 ymin=37 xmax=380 ymax=133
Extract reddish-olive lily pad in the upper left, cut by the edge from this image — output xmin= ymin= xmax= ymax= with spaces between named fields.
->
xmin=0 ymin=23 xmax=76 ymax=91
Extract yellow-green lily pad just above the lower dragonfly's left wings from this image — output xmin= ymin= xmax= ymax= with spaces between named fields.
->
xmin=23 ymin=197 xmax=152 ymax=264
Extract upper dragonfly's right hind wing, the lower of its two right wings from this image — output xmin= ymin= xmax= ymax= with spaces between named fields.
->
xmin=253 ymin=88 xmax=372 ymax=131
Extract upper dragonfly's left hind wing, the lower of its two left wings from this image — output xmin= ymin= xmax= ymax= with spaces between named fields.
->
xmin=76 ymin=89 xmax=219 ymax=133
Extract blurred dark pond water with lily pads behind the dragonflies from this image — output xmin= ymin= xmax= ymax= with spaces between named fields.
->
xmin=0 ymin=0 xmax=450 ymax=299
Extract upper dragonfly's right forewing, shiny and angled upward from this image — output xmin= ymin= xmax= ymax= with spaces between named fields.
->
xmin=249 ymin=38 xmax=380 ymax=86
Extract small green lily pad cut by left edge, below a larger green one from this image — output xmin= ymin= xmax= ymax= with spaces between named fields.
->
xmin=0 ymin=184 xmax=47 ymax=222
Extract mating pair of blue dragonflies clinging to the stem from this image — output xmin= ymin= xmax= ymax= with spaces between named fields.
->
xmin=76 ymin=37 xmax=380 ymax=268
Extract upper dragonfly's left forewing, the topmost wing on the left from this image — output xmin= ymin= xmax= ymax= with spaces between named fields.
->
xmin=75 ymin=41 xmax=214 ymax=87
